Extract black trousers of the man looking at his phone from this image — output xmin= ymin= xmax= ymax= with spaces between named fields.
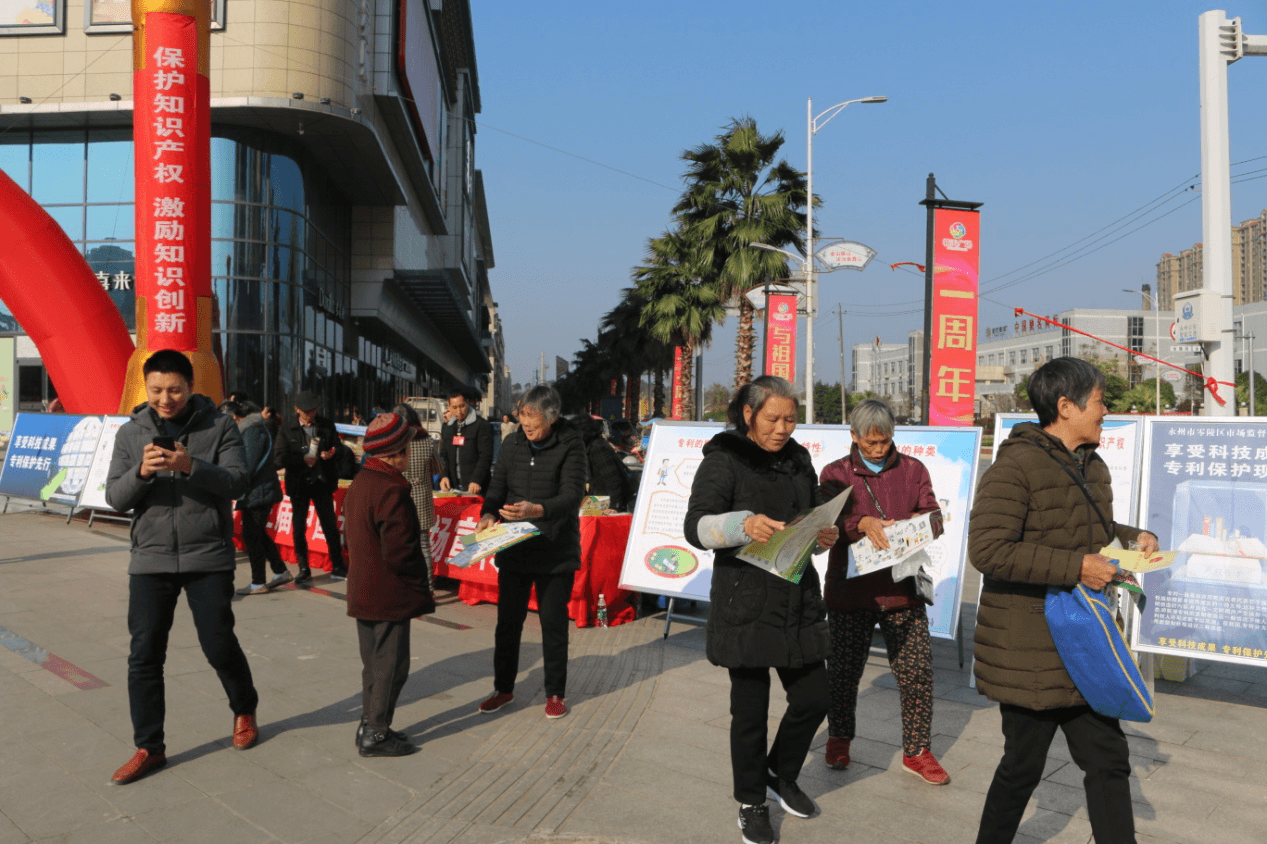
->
xmin=128 ymin=572 xmax=260 ymax=753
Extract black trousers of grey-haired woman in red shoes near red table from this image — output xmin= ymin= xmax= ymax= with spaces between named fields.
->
xmin=493 ymin=569 xmax=576 ymax=697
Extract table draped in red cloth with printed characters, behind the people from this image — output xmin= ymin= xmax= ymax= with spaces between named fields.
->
xmin=233 ymin=489 xmax=636 ymax=627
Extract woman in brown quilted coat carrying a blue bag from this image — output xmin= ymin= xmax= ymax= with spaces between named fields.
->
xmin=968 ymin=357 xmax=1157 ymax=844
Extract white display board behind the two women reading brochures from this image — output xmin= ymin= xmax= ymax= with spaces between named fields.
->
xmin=621 ymin=421 xmax=981 ymax=639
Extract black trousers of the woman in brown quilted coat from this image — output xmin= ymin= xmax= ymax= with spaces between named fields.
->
xmin=977 ymin=703 xmax=1135 ymax=844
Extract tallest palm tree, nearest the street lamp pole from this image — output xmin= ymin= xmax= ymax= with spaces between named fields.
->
xmin=673 ymin=117 xmax=807 ymax=388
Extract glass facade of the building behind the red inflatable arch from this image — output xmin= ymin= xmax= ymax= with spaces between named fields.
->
xmin=0 ymin=127 xmax=449 ymax=417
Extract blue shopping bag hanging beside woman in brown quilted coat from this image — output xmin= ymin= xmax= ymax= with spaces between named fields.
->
xmin=1045 ymin=583 xmax=1153 ymax=721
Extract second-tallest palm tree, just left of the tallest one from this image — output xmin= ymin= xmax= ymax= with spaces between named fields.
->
xmin=634 ymin=228 xmax=725 ymax=419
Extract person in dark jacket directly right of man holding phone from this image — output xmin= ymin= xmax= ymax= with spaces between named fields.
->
xmin=220 ymin=399 xmax=294 ymax=596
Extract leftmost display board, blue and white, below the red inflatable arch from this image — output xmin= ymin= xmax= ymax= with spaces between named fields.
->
xmin=0 ymin=413 xmax=101 ymax=507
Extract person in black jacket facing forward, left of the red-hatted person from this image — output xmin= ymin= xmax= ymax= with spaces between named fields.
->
xmin=274 ymin=390 xmax=347 ymax=583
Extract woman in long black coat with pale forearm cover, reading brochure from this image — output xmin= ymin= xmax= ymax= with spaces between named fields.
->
xmin=684 ymin=375 xmax=839 ymax=844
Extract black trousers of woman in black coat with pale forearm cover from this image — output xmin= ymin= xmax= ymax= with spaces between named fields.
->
xmin=730 ymin=663 xmax=827 ymax=806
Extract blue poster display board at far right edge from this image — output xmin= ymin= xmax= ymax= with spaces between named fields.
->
xmin=1134 ymin=417 xmax=1267 ymax=667
